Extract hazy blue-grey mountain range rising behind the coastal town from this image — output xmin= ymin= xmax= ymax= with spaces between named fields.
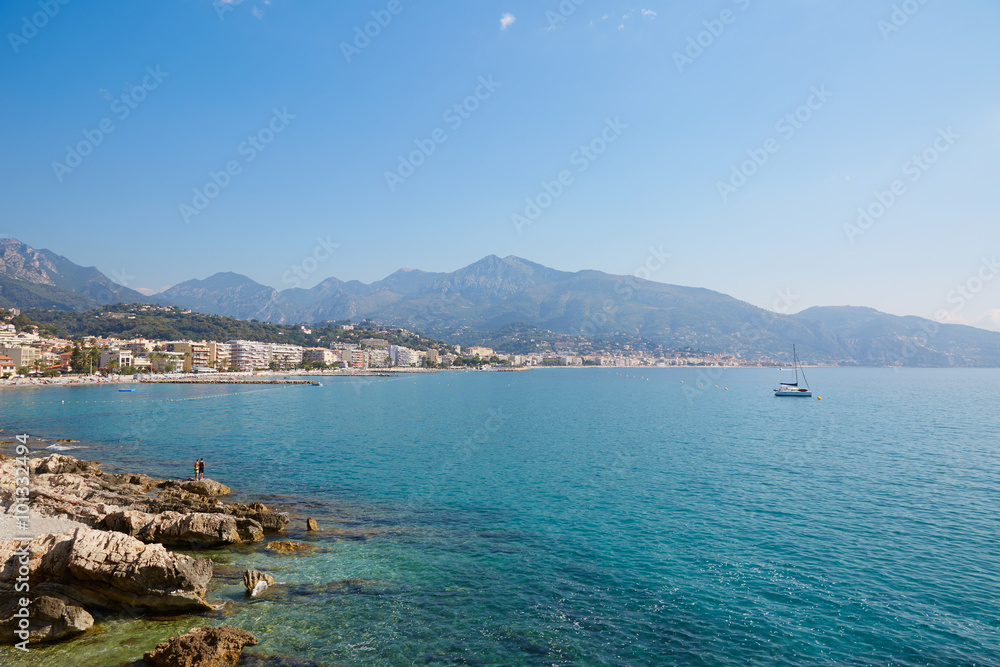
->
xmin=0 ymin=239 xmax=1000 ymax=367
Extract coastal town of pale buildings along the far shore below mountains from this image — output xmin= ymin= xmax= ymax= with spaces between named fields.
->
xmin=0 ymin=309 xmax=759 ymax=380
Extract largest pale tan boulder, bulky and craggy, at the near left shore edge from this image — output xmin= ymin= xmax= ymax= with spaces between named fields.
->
xmin=0 ymin=528 xmax=212 ymax=613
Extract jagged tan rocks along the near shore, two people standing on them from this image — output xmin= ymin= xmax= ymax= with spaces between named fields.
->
xmin=0 ymin=454 xmax=300 ymax=667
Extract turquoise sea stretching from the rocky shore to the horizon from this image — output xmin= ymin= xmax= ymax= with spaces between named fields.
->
xmin=0 ymin=369 xmax=1000 ymax=667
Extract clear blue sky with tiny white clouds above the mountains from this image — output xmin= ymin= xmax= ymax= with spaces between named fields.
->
xmin=0 ymin=0 xmax=1000 ymax=330
